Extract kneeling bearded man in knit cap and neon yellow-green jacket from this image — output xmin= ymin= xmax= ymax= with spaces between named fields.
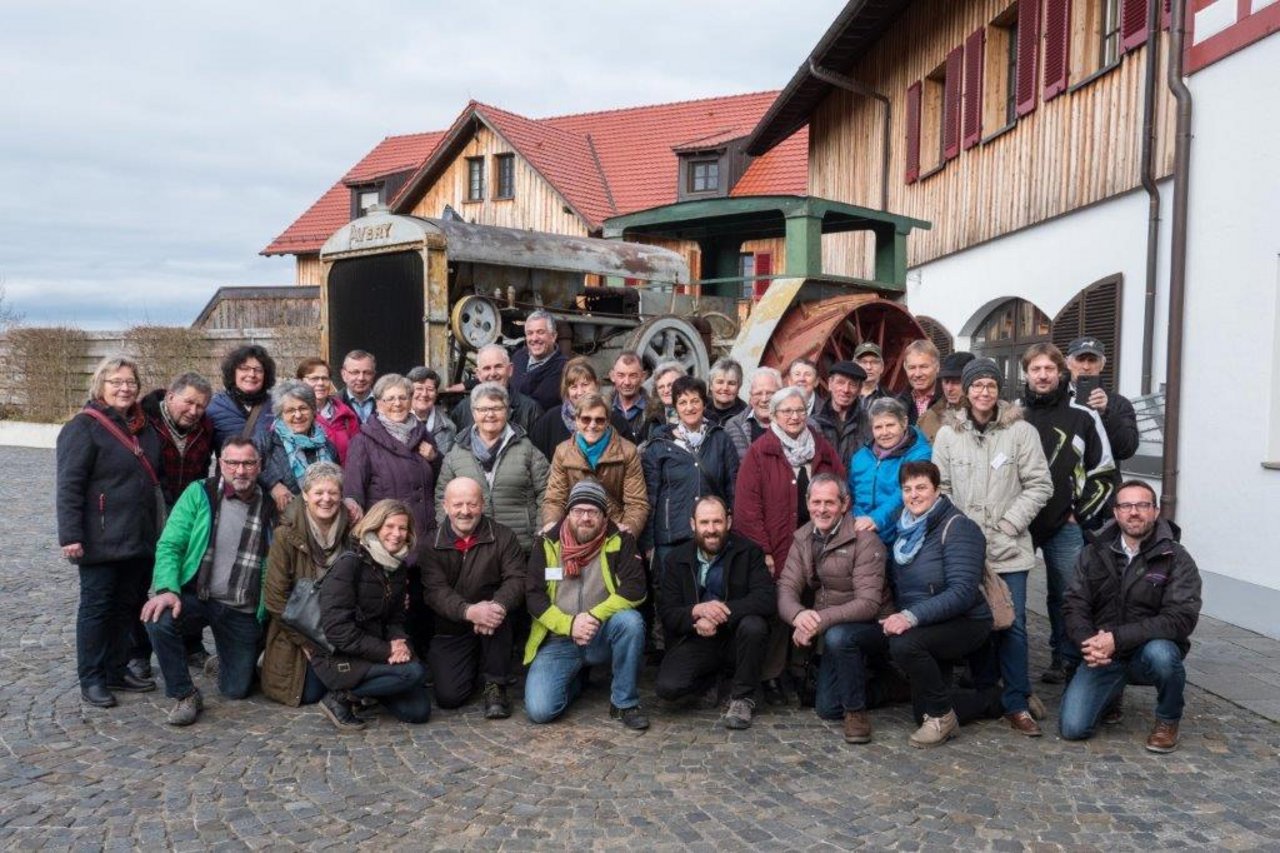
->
xmin=525 ymin=478 xmax=649 ymax=731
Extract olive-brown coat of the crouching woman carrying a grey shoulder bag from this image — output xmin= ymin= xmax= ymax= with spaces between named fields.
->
xmin=262 ymin=491 xmax=355 ymax=708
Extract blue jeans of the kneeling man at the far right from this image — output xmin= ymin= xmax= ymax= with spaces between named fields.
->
xmin=1057 ymin=639 xmax=1187 ymax=740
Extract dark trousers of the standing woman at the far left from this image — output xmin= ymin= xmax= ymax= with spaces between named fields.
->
xmin=76 ymin=557 xmax=152 ymax=688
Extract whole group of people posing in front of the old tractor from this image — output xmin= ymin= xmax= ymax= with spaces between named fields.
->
xmin=58 ymin=311 xmax=1199 ymax=752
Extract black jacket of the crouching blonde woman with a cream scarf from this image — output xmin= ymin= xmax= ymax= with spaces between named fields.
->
xmin=311 ymin=545 xmax=412 ymax=690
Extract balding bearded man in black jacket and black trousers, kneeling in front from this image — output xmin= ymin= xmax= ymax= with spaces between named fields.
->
xmin=654 ymin=496 xmax=777 ymax=729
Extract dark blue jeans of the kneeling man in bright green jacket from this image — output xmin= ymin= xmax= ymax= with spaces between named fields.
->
xmin=146 ymin=593 xmax=262 ymax=699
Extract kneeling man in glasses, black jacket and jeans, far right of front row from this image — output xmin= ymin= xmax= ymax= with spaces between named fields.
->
xmin=1059 ymin=480 xmax=1201 ymax=753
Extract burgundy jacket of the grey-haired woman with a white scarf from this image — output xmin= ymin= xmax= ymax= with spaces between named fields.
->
xmin=733 ymin=428 xmax=845 ymax=578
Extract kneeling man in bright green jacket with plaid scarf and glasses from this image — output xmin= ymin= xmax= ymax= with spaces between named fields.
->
xmin=142 ymin=437 xmax=275 ymax=726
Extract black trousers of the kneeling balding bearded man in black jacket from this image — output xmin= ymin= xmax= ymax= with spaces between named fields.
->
xmin=654 ymin=616 xmax=769 ymax=701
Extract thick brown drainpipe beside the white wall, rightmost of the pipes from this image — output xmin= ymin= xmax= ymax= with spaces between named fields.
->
xmin=1161 ymin=0 xmax=1192 ymax=520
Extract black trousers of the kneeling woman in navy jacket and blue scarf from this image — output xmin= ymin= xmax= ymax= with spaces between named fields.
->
xmin=888 ymin=619 xmax=991 ymax=721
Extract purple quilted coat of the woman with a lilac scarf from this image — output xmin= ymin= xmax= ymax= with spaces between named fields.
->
xmin=343 ymin=415 xmax=440 ymax=565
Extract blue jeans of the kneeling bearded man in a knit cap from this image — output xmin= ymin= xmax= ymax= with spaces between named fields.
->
xmin=525 ymin=610 xmax=645 ymax=722
